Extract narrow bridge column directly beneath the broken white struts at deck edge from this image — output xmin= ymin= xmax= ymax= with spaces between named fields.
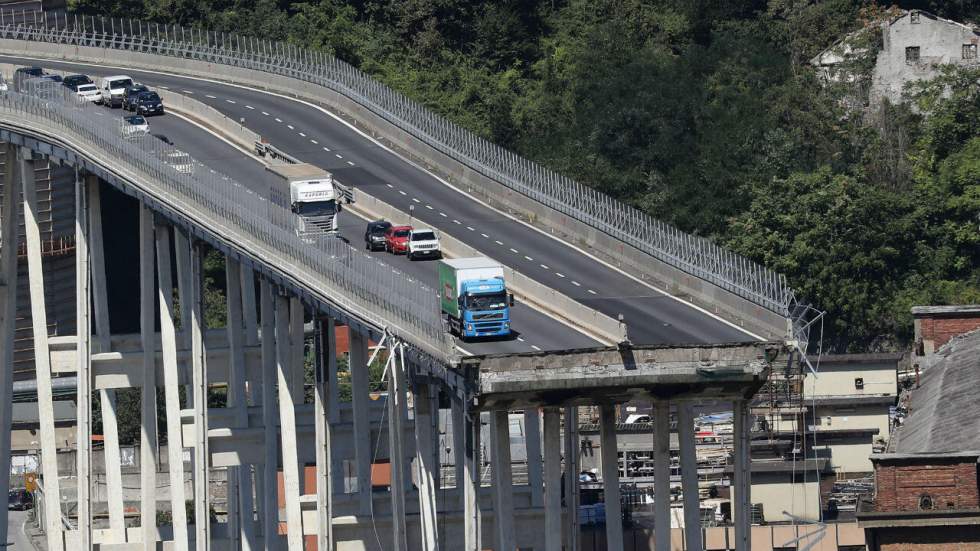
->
xmin=388 ymin=344 xmax=408 ymax=551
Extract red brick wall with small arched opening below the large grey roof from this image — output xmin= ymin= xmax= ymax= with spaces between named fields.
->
xmin=875 ymin=458 xmax=980 ymax=512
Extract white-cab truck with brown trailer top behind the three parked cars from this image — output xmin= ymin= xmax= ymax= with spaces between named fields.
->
xmin=267 ymin=163 xmax=353 ymax=239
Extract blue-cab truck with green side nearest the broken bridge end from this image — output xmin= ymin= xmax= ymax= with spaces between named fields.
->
xmin=439 ymin=257 xmax=514 ymax=339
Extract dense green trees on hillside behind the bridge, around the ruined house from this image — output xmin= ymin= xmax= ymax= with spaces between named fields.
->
xmin=74 ymin=0 xmax=980 ymax=351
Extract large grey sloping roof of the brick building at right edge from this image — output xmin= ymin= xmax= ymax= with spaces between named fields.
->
xmin=893 ymin=330 xmax=980 ymax=454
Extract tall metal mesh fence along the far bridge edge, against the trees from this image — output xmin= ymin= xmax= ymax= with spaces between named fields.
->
xmin=0 ymin=10 xmax=802 ymax=325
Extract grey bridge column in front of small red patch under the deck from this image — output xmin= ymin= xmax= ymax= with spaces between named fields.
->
xmin=348 ymin=327 xmax=372 ymax=515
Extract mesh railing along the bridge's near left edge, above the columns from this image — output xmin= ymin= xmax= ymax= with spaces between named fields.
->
xmin=0 ymin=81 xmax=452 ymax=361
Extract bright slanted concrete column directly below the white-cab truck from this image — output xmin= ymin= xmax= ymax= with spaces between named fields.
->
xmin=276 ymin=293 xmax=303 ymax=551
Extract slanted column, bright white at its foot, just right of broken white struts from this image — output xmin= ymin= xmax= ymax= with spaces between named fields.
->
xmin=414 ymin=383 xmax=439 ymax=551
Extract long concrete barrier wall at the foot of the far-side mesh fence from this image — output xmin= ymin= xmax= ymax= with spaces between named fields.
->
xmin=0 ymin=39 xmax=788 ymax=339
